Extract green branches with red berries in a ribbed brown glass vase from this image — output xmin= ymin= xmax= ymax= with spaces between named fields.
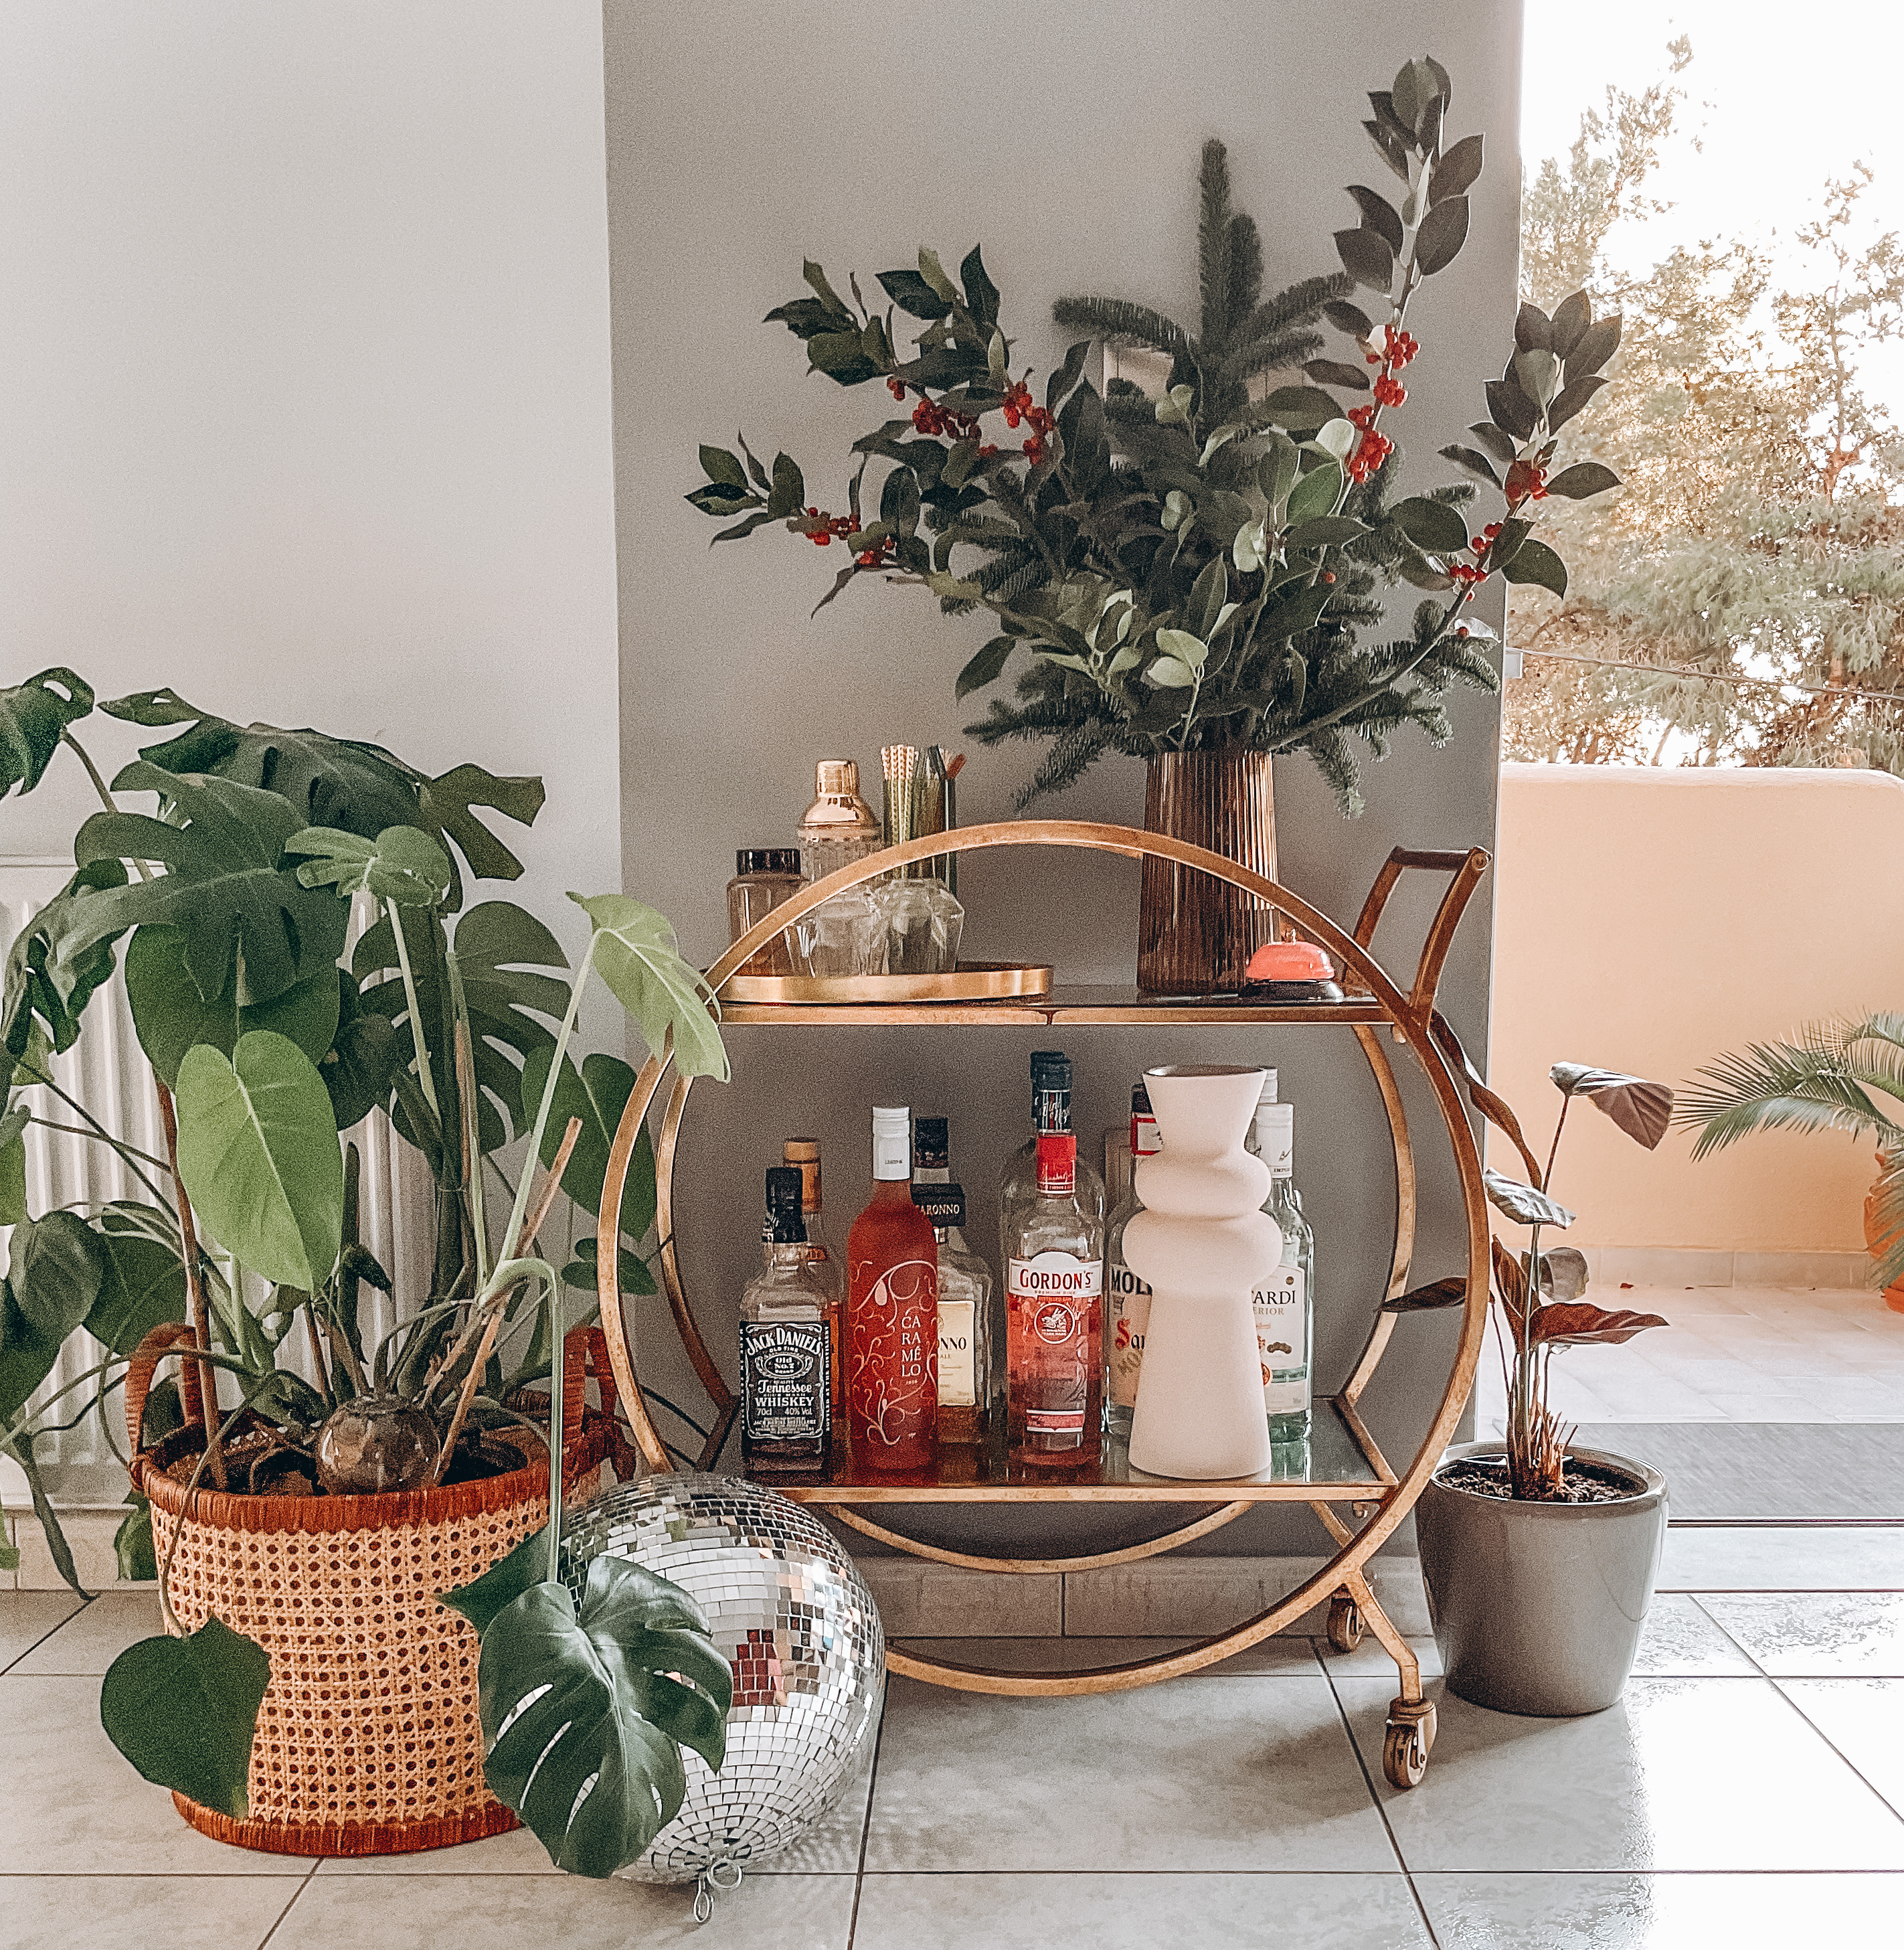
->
xmin=688 ymin=58 xmax=1620 ymax=991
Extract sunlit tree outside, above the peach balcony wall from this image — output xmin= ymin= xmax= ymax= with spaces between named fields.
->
xmin=1502 ymin=39 xmax=1904 ymax=773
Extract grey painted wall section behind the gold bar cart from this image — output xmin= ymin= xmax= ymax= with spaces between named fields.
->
xmin=606 ymin=0 xmax=1520 ymax=1552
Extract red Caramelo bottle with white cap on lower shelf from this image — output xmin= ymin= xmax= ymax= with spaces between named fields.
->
xmin=846 ymin=1106 xmax=940 ymax=1472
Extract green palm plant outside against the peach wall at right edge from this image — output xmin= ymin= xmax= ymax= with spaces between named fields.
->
xmin=1674 ymin=1010 xmax=1904 ymax=1287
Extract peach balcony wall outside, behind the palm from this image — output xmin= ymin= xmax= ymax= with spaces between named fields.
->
xmin=1489 ymin=764 xmax=1904 ymax=1252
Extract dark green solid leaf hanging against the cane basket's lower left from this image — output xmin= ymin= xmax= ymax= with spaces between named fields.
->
xmin=100 ymin=1613 xmax=271 ymax=1815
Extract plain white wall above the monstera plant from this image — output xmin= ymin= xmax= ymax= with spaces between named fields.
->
xmin=0 ymin=0 xmax=620 ymax=944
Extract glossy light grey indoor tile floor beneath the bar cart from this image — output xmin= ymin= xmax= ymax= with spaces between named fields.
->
xmin=11 ymin=1552 xmax=1904 ymax=1950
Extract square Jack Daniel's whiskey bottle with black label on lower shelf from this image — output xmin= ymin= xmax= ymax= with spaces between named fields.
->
xmin=741 ymin=1164 xmax=832 ymax=1476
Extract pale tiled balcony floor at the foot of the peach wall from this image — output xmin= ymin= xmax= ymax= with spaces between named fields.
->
xmin=1473 ymin=1281 xmax=1904 ymax=1435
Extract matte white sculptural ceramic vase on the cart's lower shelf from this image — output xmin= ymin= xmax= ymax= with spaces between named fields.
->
xmin=1124 ymin=1064 xmax=1282 ymax=1482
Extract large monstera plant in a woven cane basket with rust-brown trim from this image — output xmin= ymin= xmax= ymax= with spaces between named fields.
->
xmin=0 ymin=671 xmax=727 ymax=1874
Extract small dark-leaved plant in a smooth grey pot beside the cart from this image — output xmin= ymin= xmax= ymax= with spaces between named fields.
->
xmin=1393 ymin=1059 xmax=1672 ymax=1714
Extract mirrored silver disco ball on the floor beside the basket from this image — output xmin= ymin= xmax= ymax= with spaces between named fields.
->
xmin=564 ymin=1474 xmax=887 ymax=1882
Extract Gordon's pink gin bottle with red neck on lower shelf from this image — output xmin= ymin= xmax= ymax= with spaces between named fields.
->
xmin=1004 ymin=1057 xmax=1105 ymax=1468
